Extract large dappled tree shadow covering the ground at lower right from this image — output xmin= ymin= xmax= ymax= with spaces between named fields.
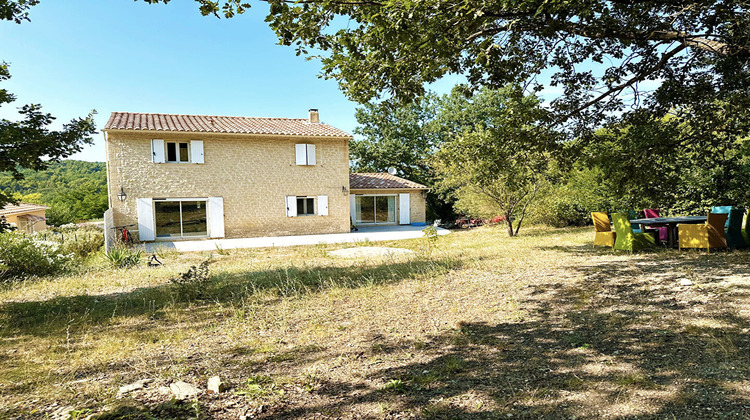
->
xmin=228 ymin=246 xmax=750 ymax=419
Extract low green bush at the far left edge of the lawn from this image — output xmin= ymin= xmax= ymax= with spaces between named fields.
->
xmin=0 ymin=232 xmax=72 ymax=278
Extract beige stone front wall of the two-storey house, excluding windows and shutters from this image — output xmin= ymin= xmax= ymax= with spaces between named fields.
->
xmin=107 ymin=130 xmax=349 ymax=238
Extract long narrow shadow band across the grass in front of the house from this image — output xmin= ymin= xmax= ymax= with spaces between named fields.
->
xmin=0 ymin=254 xmax=461 ymax=337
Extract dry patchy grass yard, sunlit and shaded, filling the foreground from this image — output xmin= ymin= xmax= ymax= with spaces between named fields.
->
xmin=0 ymin=227 xmax=750 ymax=419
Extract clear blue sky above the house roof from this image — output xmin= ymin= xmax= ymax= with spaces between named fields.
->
xmin=0 ymin=0 xmax=456 ymax=161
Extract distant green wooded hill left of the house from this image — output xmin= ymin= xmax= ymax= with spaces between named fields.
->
xmin=0 ymin=160 xmax=107 ymax=225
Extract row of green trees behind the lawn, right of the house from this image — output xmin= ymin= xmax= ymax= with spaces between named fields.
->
xmin=350 ymin=86 xmax=750 ymax=235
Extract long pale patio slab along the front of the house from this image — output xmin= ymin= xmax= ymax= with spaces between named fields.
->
xmin=145 ymin=226 xmax=450 ymax=252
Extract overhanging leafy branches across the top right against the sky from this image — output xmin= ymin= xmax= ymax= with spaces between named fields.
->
xmin=145 ymin=0 xmax=750 ymax=128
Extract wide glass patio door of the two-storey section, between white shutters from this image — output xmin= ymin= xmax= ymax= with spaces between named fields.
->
xmin=154 ymin=199 xmax=208 ymax=238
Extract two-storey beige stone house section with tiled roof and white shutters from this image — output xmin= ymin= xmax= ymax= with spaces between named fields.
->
xmin=103 ymin=110 xmax=424 ymax=241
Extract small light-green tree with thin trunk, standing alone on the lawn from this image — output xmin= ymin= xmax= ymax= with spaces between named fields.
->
xmin=432 ymin=86 xmax=559 ymax=236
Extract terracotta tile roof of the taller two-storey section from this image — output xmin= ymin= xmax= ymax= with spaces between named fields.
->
xmin=104 ymin=112 xmax=351 ymax=138
